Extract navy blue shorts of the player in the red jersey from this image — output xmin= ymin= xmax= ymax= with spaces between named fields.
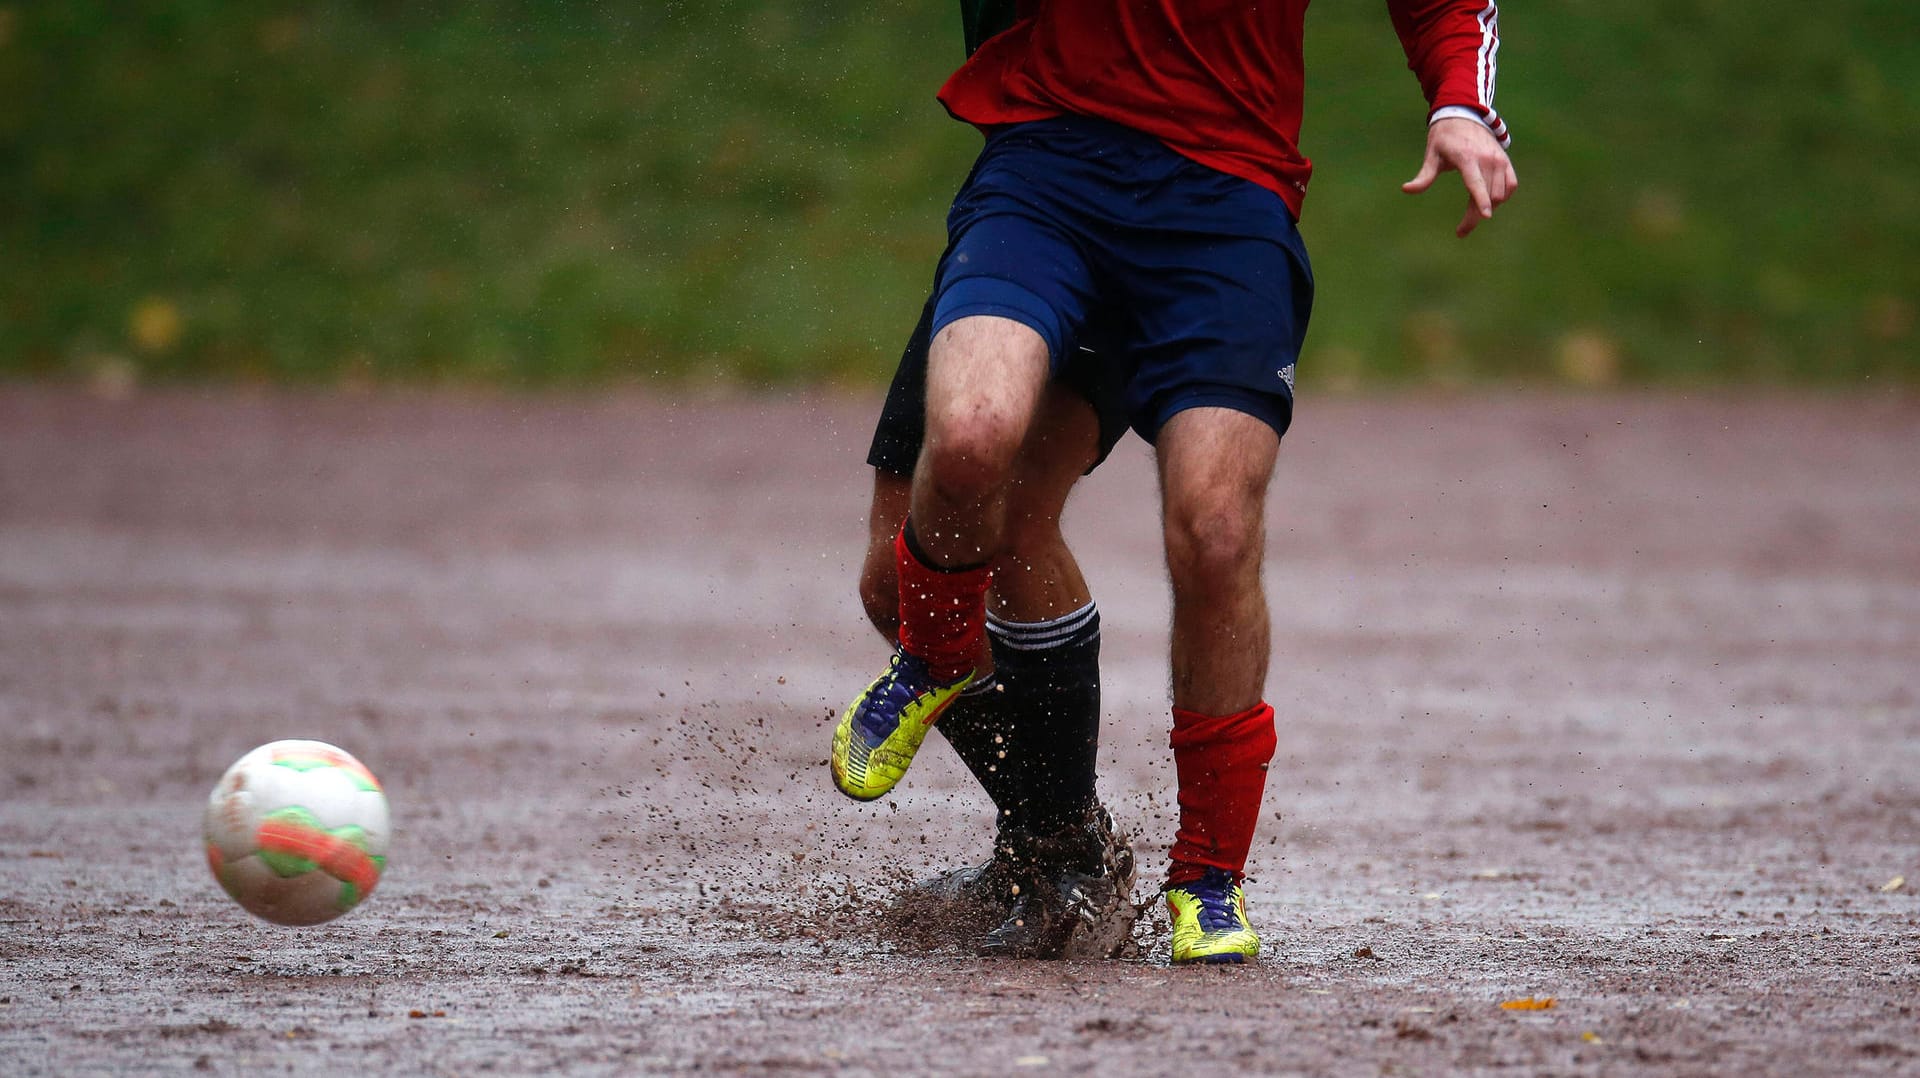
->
xmin=933 ymin=117 xmax=1313 ymax=442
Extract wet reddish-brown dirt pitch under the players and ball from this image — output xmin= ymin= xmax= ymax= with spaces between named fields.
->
xmin=0 ymin=388 xmax=1920 ymax=1076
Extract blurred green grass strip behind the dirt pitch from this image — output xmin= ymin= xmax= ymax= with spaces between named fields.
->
xmin=0 ymin=0 xmax=1920 ymax=386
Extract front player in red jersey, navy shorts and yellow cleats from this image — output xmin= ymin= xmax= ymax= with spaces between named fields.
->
xmin=829 ymin=0 xmax=1519 ymax=963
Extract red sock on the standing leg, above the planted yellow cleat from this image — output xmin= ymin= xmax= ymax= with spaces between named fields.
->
xmin=1167 ymin=703 xmax=1277 ymax=886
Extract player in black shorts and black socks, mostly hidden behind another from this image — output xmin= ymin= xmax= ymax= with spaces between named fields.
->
xmin=860 ymin=300 xmax=1137 ymax=957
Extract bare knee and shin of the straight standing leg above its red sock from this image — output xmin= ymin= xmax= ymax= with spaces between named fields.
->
xmin=1158 ymin=407 xmax=1281 ymax=715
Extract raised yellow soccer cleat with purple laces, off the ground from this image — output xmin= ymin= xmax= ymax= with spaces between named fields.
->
xmin=828 ymin=651 xmax=973 ymax=801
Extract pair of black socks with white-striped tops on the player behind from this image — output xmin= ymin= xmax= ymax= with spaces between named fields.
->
xmin=935 ymin=603 xmax=1100 ymax=834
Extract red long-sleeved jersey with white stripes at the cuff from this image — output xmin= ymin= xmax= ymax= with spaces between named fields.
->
xmin=939 ymin=0 xmax=1507 ymax=217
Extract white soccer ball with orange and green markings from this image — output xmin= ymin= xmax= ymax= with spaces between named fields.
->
xmin=205 ymin=742 xmax=390 ymax=924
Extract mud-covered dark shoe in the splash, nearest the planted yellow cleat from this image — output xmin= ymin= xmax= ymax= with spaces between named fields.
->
xmin=977 ymin=809 xmax=1139 ymax=959
